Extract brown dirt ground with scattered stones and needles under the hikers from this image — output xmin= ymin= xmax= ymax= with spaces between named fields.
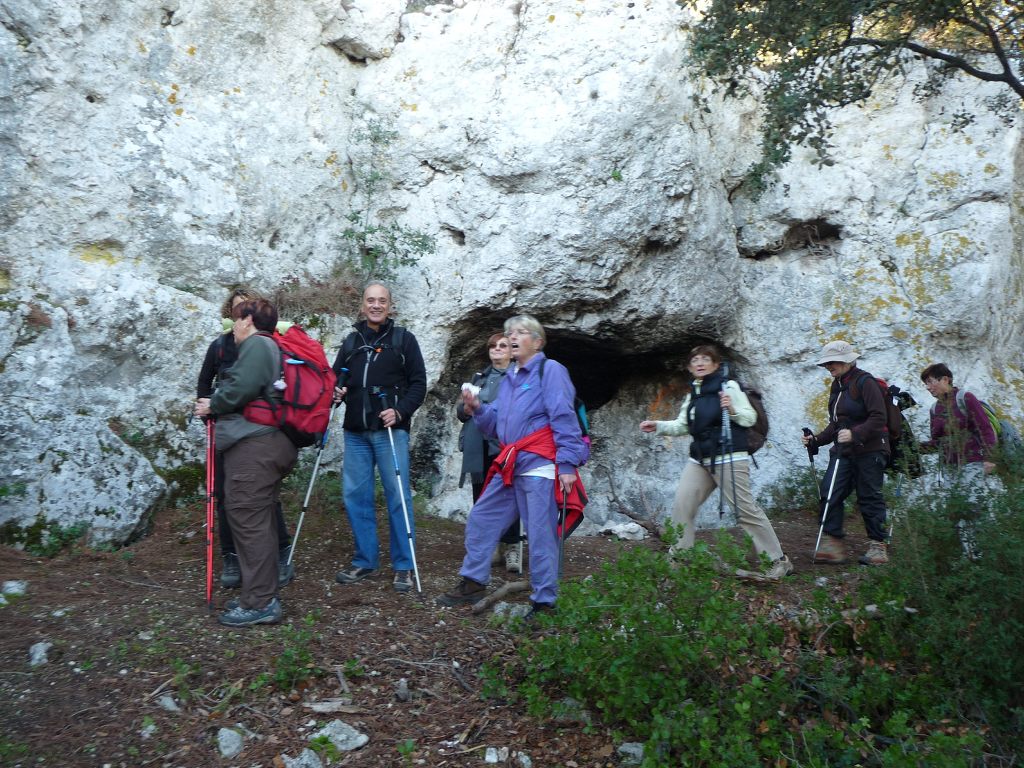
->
xmin=0 ymin=487 xmax=880 ymax=768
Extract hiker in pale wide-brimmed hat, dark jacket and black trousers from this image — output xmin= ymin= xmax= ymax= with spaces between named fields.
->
xmin=803 ymin=339 xmax=892 ymax=565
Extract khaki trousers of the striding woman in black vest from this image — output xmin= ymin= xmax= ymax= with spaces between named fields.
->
xmin=672 ymin=459 xmax=782 ymax=560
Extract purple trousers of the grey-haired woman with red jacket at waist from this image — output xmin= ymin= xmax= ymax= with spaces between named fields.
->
xmin=459 ymin=476 xmax=558 ymax=603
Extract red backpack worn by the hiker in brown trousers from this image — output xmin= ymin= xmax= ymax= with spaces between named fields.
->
xmin=242 ymin=326 xmax=336 ymax=447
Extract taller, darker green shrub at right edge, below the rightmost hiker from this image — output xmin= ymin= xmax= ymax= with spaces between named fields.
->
xmin=861 ymin=482 xmax=1024 ymax=735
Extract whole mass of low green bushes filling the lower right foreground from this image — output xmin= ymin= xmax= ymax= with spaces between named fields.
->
xmin=507 ymin=481 xmax=1024 ymax=768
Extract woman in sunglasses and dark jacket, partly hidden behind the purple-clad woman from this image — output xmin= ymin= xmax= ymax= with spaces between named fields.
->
xmin=455 ymin=333 xmax=522 ymax=573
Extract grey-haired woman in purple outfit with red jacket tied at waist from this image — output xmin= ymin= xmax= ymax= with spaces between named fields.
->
xmin=437 ymin=314 xmax=590 ymax=614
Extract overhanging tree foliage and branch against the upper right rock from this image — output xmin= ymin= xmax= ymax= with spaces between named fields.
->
xmin=679 ymin=0 xmax=1024 ymax=188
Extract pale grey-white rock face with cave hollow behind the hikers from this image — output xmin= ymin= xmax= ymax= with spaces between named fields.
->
xmin=0 ymin=0 xmax=1024 ymax=541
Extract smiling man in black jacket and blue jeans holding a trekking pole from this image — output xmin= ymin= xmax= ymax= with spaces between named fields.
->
xmin=334 ymin=282 xmax=427 ymax=592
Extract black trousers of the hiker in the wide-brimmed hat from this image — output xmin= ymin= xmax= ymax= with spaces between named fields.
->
xmin=820 ymin=451 xmax=887 ymax=542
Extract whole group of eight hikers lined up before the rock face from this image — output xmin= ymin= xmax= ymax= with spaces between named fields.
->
xmin=195 ymin=282 xmax=996 ymax=627
